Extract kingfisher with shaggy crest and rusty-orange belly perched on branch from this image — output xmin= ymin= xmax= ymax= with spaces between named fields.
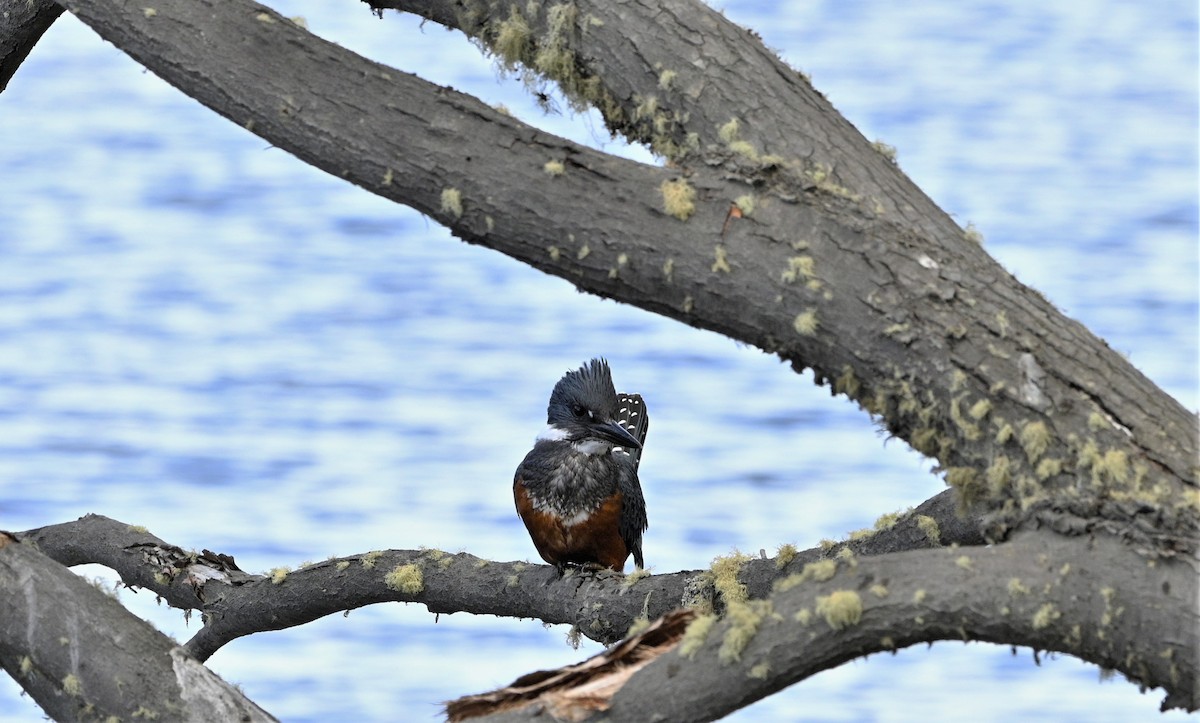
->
xmin=512 ymin=359 xmax=649 ymax=573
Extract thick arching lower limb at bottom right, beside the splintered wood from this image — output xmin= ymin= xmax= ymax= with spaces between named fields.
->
xmin=458 ymin=531 xmax=1200 ymax=721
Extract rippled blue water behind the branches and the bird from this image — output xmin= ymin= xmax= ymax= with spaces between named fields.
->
xmin=0 ymin=0 xmax=1198 ymax=722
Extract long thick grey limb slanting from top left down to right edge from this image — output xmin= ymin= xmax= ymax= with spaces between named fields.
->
xmin=44 ymin=0 xmax=1200 ymax=554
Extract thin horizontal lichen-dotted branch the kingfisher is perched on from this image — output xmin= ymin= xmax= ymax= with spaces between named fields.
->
xmin=18 ymin=504 xmax=969 ymax=661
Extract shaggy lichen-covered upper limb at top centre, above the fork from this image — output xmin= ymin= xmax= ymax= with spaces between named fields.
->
xmin=362 ymin=0 xmax=961 ymax=235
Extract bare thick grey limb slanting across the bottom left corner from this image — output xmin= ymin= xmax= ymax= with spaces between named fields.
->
xmin=0 ymin=533 xmax=275 ymax=721
